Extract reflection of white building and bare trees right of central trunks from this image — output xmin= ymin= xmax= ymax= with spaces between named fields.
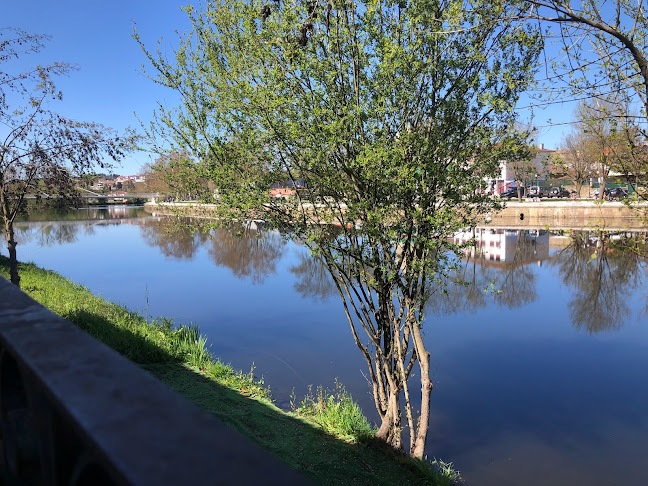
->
xmin=426 ymin=228 xmax=648 ymax=333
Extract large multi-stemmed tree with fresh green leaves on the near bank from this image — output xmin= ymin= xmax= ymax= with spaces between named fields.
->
xmin=135 ymin=0 xmax=542 ymax=457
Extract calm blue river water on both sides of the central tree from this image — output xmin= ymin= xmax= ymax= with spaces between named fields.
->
xmin=8 ymin=207 xmax=648 ymax=486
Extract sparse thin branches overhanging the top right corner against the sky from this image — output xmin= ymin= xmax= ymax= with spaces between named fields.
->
xmin=526 ymin=0 xmax=648 ymax=197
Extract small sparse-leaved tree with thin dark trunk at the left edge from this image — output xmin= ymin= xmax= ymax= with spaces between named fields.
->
xmin=0 ymin=28 xmax=133 ymax=285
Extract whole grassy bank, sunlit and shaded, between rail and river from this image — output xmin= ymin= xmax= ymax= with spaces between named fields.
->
xmin=0 ymin=256 xmax=454 ymax=485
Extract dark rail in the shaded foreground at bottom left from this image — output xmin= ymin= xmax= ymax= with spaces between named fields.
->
xmin=0 ymin=277 xmax=307 ymax=486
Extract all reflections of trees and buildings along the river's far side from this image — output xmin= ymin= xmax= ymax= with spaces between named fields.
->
xmin=16 ymin=206 xmax=648 ymax=333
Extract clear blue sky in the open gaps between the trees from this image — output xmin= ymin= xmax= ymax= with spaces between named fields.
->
xmin=5 ymin=0 xmax=574 ymax=175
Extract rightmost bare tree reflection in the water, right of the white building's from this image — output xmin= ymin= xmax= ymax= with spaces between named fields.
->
xmin=552 ymin=231 xmax=646 ymax=333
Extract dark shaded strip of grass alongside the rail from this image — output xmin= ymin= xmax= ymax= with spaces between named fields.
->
xmin=63 ymin=310 xmax=435 ymax=485
